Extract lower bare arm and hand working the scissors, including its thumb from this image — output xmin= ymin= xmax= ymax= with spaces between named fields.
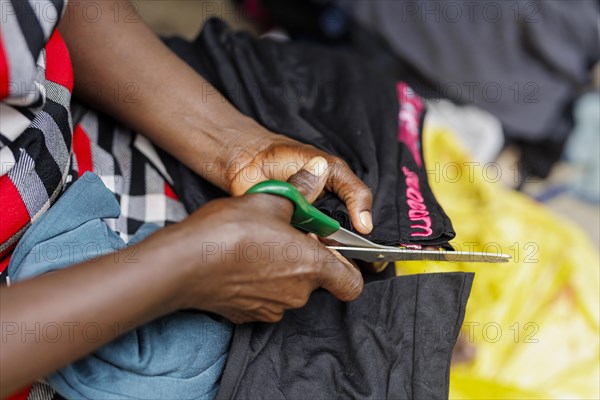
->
xmin=0 ymin=158 xmax=363 ymax=397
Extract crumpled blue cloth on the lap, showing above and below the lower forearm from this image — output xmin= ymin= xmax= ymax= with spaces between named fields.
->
xmin=8 ymin=173 xmax=233 ymax=399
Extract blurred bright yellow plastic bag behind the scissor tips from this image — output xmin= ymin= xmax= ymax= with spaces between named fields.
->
xmin=396 ymin=125 xmax=600 ymax=399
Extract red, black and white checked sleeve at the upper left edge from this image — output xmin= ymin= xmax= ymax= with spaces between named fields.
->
xmin=0 ymin=0 xmax=73 ymax=259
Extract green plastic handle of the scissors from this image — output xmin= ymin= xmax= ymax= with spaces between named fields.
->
xmin=246 ymin=180 xmax=340 ymax=237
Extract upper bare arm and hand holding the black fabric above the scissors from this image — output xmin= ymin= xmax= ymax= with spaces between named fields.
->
xmin=59 ymin=0 xmax=372 ymax=233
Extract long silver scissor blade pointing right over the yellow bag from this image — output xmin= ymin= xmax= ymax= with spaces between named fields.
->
xmin=329 ymin=245 xmax=511 ymax=263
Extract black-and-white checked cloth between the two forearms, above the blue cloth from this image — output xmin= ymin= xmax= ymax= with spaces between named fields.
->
xmin=72 ymin=106 xmax=187 ymax=242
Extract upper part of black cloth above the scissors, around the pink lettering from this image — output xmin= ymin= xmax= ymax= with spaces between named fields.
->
xmin=162 ymin=20 xmax=454 ymax=246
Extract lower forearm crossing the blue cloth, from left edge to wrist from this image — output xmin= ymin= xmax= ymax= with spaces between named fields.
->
xmin=0 ymin=225 xmax=196 ymax=397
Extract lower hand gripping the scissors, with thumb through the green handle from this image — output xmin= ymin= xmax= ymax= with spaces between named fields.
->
xmin=173 ymin=157 xmax=363 ymax=323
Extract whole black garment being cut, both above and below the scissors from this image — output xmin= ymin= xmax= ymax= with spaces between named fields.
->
xmin=162 ymin=20 xmax=473 ymax=399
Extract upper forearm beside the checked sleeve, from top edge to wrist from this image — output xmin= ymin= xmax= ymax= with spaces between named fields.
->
xmin=59 ymin=0 xmax=265 ymax=189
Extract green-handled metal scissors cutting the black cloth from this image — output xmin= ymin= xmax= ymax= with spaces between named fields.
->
xmin=246 ymin=180 xmax=511 ymax=263
